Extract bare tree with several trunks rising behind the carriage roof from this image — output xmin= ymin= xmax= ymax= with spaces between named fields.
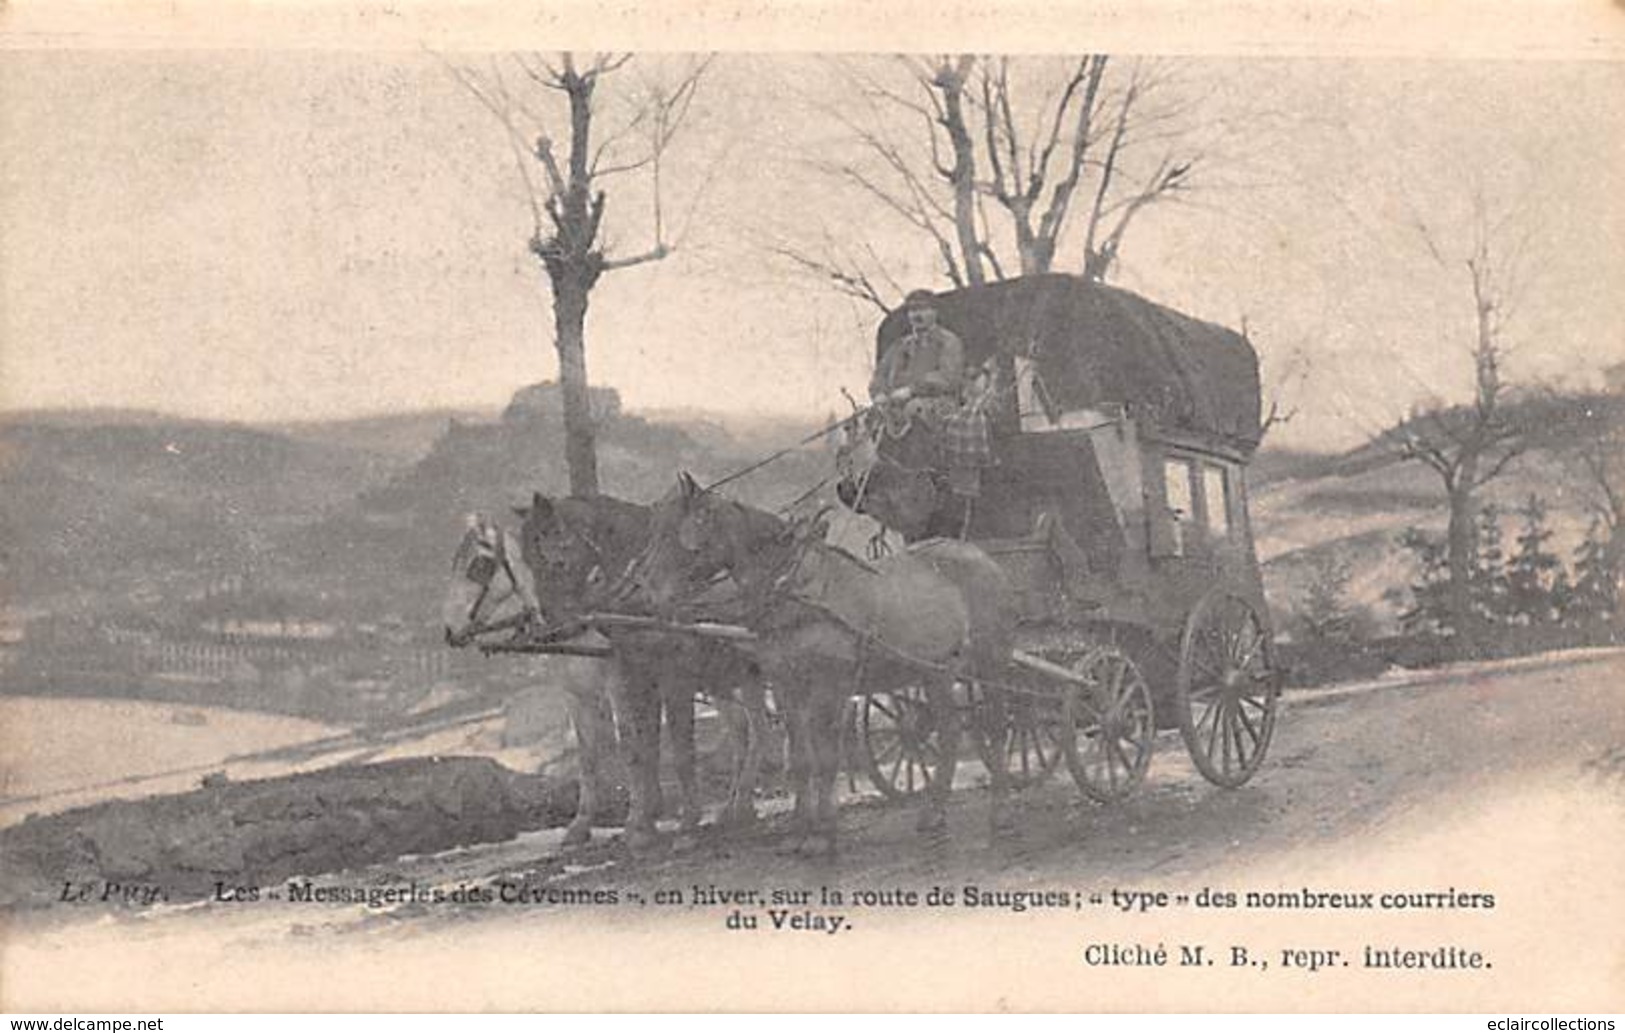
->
xmin=774 ymin=54 xmax=1204 ymax=309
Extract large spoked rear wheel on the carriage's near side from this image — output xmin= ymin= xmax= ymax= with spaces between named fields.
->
xmin=1175 ymin=591 xmax=1281 ymax=789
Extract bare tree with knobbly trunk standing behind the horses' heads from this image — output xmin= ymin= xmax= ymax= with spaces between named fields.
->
xmin=449 ymin=54 xmax=710 ymax=495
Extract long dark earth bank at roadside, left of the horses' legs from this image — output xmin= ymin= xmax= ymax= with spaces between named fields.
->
xmin=0 ymin=757 xmax=611 ymax=906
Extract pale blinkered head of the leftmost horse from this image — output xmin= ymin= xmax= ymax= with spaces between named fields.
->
xmin=440 ymin=513 xmax=541 ymax=646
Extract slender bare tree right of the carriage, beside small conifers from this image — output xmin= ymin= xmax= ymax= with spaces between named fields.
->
xmin=1385 ymin=219 xmax=1537 ymax=635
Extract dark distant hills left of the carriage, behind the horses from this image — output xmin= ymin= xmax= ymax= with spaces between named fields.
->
xmin=0 ymin=383 xmax=827 ymax=637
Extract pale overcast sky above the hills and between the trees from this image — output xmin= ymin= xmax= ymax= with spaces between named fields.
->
xmin=0 ymin=50 xmax=1625 ymax=447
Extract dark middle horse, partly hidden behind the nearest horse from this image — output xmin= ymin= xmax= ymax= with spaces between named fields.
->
xmin=517 ymin=494 xmax=765 ymax=846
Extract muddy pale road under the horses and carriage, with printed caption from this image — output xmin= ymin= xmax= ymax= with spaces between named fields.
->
xmin=0 ymin=656 xmax=1625 ymax=1010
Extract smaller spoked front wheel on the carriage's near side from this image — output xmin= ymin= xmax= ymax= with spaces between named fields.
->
xmin=1061 ymin=645 xmax=1157 ymax=804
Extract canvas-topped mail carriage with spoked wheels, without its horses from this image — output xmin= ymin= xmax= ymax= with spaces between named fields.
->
xmin=842 ymin=276 xmax=1279 ymax=801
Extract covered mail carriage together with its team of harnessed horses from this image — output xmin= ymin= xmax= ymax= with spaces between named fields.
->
xmin=447 ymin=269 xmax=1279 ymax=849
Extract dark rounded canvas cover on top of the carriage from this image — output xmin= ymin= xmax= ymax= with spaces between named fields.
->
xmin=876 ymin=274 xmax=1261 ymax=453
